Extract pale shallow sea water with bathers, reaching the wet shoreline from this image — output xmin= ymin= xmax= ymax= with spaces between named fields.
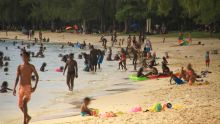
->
xmin=0 ymin=41 xmax=138 ymax=124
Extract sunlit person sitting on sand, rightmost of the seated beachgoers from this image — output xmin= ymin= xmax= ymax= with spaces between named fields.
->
xmin=186 ymin=63 xmax=196 ymax=85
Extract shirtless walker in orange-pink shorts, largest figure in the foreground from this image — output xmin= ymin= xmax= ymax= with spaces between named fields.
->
xmin=13 ymin=52 xmax=39 ymax=124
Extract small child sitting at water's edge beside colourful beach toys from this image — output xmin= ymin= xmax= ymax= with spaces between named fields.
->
xmin=80 ymin=97 xmax=92 ymax=116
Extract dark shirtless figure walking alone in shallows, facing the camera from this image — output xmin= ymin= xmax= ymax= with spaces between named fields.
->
xmin=63 ymin=53 xmax=78 ymax=91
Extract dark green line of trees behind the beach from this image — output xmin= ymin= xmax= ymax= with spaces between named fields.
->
xmin=0 ymin=0 xmax=220 ymax=33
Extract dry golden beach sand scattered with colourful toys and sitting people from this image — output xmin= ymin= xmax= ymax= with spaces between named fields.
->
xmin=0 ymin=32 xmax=220 ymax=124
